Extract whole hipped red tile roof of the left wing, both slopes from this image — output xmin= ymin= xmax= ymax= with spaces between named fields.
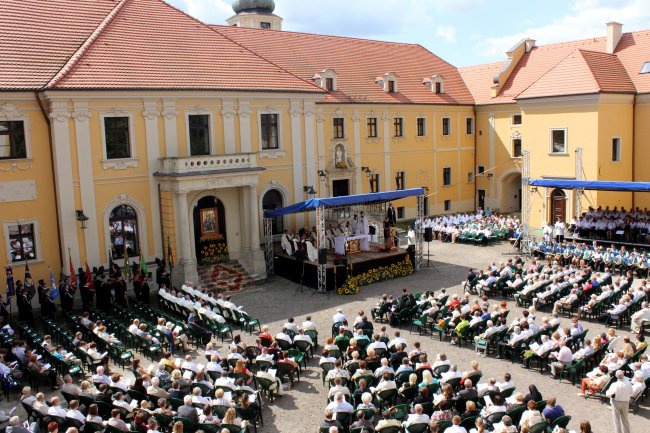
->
xmin=0 ymin=0 xmax=322 ymax=93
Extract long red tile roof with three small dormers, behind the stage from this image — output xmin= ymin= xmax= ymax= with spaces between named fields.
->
xmin=213 ymin=26 xmax=474 ymax=104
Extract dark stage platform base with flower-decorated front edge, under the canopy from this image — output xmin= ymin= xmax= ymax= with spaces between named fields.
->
xmin=274 ymin=244 xmax=415 ymax=291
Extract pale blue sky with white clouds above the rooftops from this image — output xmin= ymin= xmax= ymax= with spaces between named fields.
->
xmin=166 ymin=0 xmax=650 ymax=66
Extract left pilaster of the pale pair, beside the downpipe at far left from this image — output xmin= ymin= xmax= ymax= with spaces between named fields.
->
xmin=49 ymin=101 xmax=79 ymax=270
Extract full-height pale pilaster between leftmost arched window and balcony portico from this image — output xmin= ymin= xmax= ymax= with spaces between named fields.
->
xmin=142 ymin=101 xmax=164 ymax=257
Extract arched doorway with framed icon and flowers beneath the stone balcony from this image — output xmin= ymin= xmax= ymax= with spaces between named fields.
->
xmin=192 ymin=196 xmax=228 ymax=265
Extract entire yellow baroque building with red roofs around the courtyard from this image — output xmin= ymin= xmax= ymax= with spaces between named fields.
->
xmin=0 ymin=0 xmax=650 ymax=282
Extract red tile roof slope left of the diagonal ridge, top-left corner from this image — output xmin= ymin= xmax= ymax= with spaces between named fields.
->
xmin=0 ymin=0 xmax=119 ymax=90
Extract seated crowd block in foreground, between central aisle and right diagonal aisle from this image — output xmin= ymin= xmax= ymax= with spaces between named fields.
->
xmin=319 ymin=304 xmax=588 ymax=433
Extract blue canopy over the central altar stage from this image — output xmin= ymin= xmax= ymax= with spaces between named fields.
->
xmin=264 ymin=188 xmax=424 ymax=218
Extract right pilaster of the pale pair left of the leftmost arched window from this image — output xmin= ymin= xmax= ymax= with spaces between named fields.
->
xmin=72 ymin=102 xmax=101 ymax=265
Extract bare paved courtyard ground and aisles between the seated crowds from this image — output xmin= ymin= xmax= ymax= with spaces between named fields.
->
xmin=1 ymin=242 xmax=650 ymax=433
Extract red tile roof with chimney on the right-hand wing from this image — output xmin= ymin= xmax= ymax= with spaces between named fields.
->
xmin=460 ymin=30 xmax=650 ymax=104
